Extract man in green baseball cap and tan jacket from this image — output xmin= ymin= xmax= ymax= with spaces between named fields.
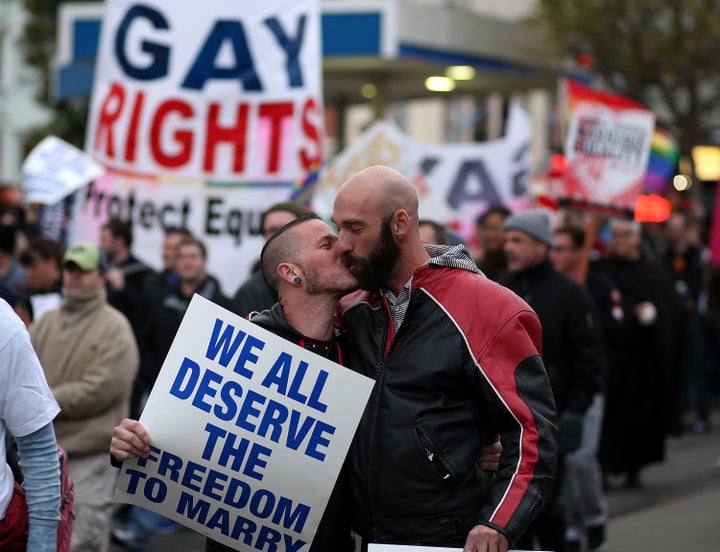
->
xmin=30 ymin=242 xmax=139 ymax=551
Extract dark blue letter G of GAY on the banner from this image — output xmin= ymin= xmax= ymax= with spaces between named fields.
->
xmin=115 ymin=5 xmax=170 ymax=80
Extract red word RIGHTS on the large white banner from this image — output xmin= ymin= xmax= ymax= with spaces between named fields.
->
xmin=89 ymin=83 xmax=322 ymax=178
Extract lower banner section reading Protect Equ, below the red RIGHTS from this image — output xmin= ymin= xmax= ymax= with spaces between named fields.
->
xmin=73 ymin=172 xmax=256 ymax=296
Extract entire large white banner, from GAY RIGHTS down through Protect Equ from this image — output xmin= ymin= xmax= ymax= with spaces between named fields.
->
xmin=72 ymin=0 xmax=324 ymax=294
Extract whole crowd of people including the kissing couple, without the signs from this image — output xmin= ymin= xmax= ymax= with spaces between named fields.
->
xmin=0 ymin=166 xmax=720 ymax=552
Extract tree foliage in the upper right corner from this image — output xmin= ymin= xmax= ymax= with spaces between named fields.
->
xmin=534 ymin=0 xmax=720 ymax=151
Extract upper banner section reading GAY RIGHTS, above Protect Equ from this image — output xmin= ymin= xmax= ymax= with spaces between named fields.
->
xmin=85 ymin=0 xmax=323 ymax=184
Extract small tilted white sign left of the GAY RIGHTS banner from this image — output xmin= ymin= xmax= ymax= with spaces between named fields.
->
xmin=22 ymin=136 xmax=105 ymax=205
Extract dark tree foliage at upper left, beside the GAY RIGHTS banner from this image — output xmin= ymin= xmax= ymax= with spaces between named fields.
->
xmin=20 ymin=0 xmax=92 ymax=148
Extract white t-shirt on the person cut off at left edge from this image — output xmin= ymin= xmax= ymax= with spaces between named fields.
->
xmin=0 ymin=299 xmax=60 ymax=519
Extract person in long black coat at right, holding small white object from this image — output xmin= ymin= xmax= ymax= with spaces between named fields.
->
xmin=597 ymin=220 xmax=682 ymax=487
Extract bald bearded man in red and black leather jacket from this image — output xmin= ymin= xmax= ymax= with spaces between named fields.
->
xmin=332 ymin=166 xmax=557 ymax=552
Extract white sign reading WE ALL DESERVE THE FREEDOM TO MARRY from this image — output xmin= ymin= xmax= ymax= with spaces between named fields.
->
xmin=115 ymin=295 xmax=373 ymax=551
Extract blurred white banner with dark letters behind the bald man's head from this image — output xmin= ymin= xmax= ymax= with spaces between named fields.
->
xmin=314 ymin=103 xmax=531 ymax=235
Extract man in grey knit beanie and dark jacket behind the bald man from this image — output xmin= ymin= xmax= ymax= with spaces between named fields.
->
xmin=500 ymin=210 xmax=605 ymax=550
